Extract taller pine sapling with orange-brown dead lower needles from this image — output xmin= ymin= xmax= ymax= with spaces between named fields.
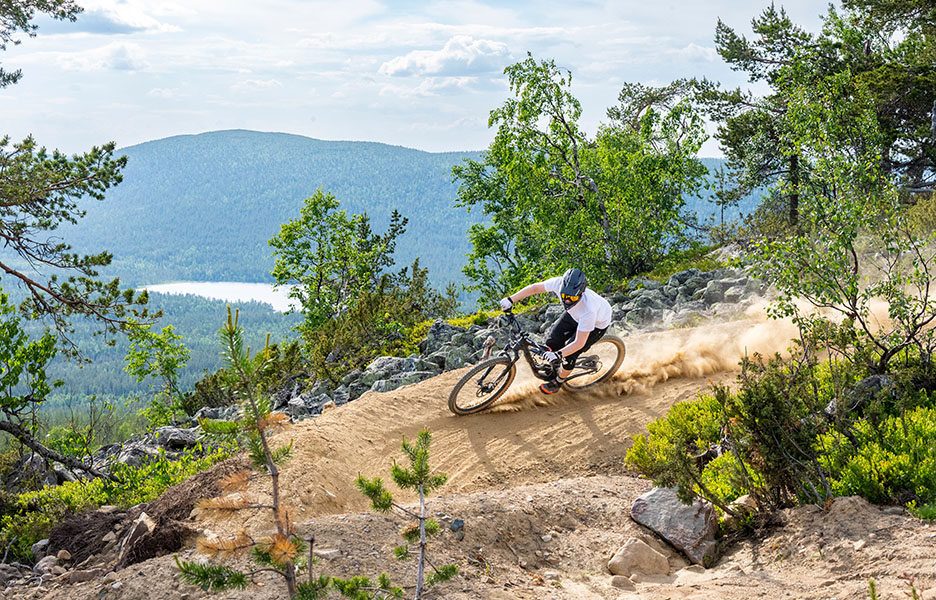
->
xmin=176 ymin=307 xmax=330 ymax=600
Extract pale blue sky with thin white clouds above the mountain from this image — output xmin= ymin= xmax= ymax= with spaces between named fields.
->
xmin=0 ymin=0 xmax=827 ymax=156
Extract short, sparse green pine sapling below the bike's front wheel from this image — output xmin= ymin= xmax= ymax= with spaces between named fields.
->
xmin=352 ymin=429 xmax=458 ymax=600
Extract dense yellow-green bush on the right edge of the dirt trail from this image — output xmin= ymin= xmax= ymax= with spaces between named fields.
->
xmin=627 ymin=352 xmax=936 ymax=514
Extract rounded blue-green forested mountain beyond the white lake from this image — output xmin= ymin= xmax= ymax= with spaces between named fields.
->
xmin=62 ymin=130 xmax=480 ymax=285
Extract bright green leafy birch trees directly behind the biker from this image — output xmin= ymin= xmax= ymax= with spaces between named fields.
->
xmin=453 ymin=56 xmax=706 ymax=300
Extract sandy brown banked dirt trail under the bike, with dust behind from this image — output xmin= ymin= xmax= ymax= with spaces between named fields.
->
xmin=200 ymin=319 xmax=790 ymax=534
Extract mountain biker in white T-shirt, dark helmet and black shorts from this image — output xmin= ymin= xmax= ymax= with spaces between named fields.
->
xmin=500 ymin=269 xmax=611 ymax=394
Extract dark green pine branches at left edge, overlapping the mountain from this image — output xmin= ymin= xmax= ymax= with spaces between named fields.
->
xmin=0 ymin=133 xmax=149 ymax=353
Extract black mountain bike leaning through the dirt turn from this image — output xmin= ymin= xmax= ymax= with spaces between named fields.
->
xmin=449 ymin=310 xmax=625 ymax=415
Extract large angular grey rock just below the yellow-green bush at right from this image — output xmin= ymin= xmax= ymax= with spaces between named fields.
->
xmin=631 ymin=488 xmax=718 ymax=566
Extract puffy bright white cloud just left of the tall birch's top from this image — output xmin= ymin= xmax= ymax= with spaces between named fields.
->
xmin=378 ymin=35 xmax=510 ymax=77
